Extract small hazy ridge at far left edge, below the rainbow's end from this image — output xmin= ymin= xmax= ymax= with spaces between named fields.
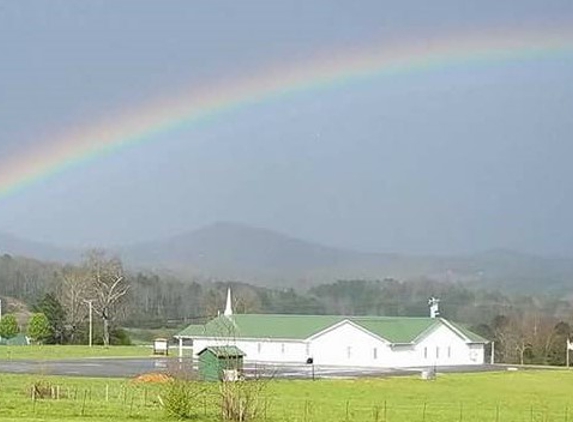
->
xmin=0 ymin=233 xmax=81 ymax=262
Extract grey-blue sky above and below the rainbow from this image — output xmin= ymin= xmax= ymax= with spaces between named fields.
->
xmin=0 ymin=0 xmax=573 ymax=256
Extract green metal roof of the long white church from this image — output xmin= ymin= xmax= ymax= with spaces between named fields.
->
xmin=177 ymin=314 xmax=487 ymax=344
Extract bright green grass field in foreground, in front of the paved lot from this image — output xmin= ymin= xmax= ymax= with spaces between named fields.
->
xmin=0 ymin=371 xmax=573 ymax=422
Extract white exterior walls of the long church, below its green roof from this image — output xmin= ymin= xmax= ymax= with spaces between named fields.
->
xmin=182 ymin=322 xmax=485 ymax=368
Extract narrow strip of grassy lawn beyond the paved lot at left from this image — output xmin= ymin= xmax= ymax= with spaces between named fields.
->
xmin=0 ymin=345 xmax=151 ymax=360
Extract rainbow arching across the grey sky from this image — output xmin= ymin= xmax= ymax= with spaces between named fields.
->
xmin=0 ymin=29 xmax=573 ymax=200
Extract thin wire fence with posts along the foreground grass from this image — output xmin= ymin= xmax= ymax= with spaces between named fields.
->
xmin=15 ymin=383 xmax=573 ymax=422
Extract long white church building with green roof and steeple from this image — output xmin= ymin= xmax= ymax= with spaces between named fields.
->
xmin=175 ymin=291 xmax=488 ymax=368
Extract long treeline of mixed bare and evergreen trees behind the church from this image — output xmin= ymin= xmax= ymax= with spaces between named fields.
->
xmin=0 ymin=251 xmax=573 ymax=364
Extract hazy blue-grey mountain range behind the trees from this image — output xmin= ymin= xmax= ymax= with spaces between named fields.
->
xmin=0 ymin=223 xmax=573 ymax=293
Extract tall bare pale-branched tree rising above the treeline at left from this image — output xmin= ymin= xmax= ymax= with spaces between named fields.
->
xmin=85 ymin=250 xmax=129 ymax=346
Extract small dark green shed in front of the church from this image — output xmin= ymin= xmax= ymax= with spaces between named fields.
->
xmin=198 ymin=346 xmax=245 ymax=381
